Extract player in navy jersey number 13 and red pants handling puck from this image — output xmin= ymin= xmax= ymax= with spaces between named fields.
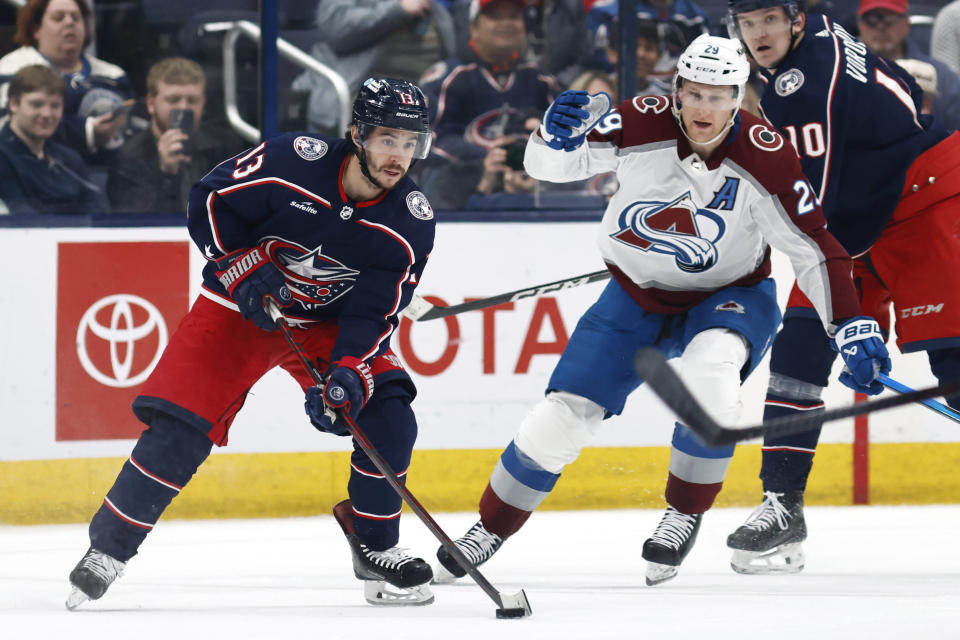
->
xmin=67 ymin=78 xmax=435 ymax=609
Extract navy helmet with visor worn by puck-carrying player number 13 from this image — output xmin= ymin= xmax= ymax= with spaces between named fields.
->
xmin=353 ymin=78 xmax=431 ymax=160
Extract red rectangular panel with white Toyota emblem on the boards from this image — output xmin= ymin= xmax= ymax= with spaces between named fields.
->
xmin=56 ymin=242 xmax=191 ymax=440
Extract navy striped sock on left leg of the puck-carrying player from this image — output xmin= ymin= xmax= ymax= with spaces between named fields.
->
xmin=90 ymin=413 xmax=213 ymax=562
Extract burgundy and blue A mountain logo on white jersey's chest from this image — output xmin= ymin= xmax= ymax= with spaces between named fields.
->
xmin=610 ymin=191 xmax=726 ymax=273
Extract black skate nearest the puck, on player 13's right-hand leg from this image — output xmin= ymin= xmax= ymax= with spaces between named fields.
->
xmin=333 ymin=500 xmax=433 ymax=605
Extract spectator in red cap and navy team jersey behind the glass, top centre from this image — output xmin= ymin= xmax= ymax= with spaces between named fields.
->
xmin=418 ymin=0 xmax=558 ymax=209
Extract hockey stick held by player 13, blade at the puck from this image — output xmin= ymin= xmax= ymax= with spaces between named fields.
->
xmin=264 ymin=298 xmax=533 ymax=618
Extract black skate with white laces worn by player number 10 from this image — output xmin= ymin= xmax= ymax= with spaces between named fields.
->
xmin=727 ymin=491 xmax=807 ymax=574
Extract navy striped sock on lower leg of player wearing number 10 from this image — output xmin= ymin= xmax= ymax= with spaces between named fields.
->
xmin=760 ymin=394 xmax=823 ymax=493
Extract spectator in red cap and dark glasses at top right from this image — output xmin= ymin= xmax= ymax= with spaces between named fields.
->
xmin=857 ymin=0 xmax=960 ymax=131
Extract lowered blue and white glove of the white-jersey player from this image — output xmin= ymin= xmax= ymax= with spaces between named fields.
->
xmin=833 ymin=316 xmax=891 ymax=396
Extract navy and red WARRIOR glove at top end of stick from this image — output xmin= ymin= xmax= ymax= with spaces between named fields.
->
xmin=217 ymin=247 xmax=293 ymax=331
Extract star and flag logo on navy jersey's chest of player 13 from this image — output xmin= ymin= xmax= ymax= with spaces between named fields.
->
xmin=264 ymin=238 xmax=360 ymax=309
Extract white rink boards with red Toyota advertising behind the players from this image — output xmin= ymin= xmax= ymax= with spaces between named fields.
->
xmin=0 ymin=223 xmax=944 ymax=460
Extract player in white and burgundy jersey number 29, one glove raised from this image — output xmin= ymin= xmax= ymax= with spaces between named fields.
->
xmin=436 ymin=35 xmax=887 ymax=585
